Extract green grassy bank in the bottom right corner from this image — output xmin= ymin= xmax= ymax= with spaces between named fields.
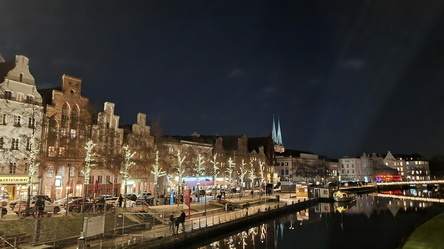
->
xmin=402 ymin=213 xmax=444 ymax=249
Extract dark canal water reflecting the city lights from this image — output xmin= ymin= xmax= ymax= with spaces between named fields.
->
xmin=196 ymin=189 xmax=444 ymax=249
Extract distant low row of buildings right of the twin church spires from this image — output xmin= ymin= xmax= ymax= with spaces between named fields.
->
xmin=274 ymin=150 xmax=430 ymax=183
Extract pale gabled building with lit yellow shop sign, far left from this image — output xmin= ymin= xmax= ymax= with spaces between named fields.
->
xmin=0 ymin=55 xmax=43 ymax=199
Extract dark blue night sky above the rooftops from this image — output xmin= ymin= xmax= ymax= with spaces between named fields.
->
xmin=0 ymin=0 xmax=444 ymax=158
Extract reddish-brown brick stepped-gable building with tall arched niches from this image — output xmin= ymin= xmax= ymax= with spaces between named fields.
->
xmin=40 ymin=75 xmax=94 ymax=199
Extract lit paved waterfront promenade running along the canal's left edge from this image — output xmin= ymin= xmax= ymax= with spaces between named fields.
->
xmin=63 ymin=194 xmax=308 ymax=248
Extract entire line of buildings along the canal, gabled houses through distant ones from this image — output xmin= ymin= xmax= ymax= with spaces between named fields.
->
xmin=0 ymin=55 xmax=430 ymax=202
